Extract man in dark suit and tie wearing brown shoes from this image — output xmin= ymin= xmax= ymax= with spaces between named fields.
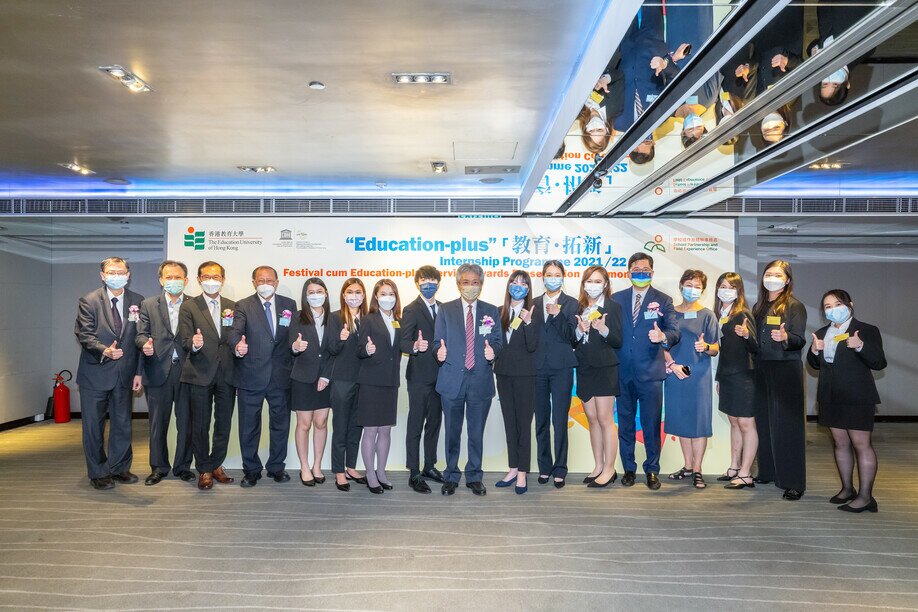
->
xmin=179 ymin=261 xmax=236 ymax=491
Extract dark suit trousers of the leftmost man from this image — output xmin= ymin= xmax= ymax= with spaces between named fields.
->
xmin=80 ymin=387 xmax=134 ymax=478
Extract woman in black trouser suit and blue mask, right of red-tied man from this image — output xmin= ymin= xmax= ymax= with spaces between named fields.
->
xmin=494 ymin=270 xmax=539 ymax=495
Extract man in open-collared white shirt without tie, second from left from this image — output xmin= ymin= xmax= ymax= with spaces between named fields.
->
xmin=134 ymin=260 xmax=196 ymax=486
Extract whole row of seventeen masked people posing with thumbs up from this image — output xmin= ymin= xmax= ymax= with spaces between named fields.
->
xmin=75 ymin=252 xmax=886 ymax=512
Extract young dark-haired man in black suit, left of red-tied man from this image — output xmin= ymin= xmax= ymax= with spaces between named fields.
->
xmin=401 ymin=266 xmax=443 ymax=493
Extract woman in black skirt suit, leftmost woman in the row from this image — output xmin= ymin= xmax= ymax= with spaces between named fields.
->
xmin=289 ymin=278 xmax=331 ymax=487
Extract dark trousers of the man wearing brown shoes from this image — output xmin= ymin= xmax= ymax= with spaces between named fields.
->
xmin=184 ymin=372 xmax=236 ymax=474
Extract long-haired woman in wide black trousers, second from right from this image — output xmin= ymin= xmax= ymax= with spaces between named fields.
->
xmin=752 ymin=259 xmax=806 ymax=501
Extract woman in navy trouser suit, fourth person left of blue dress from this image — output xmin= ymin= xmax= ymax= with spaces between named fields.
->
xmin=532 ymin=259 xmax=579 ymax=489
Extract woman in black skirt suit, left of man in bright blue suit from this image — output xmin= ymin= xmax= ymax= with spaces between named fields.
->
xmin=574 ymin=266 xmax=622 ymax=487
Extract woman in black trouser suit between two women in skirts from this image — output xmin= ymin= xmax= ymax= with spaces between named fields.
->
xmin=327 ymin=277 xmax=367 ymax=491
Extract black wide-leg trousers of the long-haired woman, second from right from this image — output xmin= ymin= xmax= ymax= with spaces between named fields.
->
xmin=755 ymin=360 xmax=806 ymax=491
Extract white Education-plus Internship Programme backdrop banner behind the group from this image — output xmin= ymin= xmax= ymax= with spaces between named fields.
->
xmin=167 ymin=216 xmax=735 ymax=472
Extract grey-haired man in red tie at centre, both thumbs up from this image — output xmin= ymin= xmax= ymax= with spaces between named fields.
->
xmin=432 ymin=264 xmax=504 ymax=495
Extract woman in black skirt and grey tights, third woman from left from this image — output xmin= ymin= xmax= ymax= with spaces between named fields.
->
xmin=357 ymin=278 xmax=406 ymax=494
